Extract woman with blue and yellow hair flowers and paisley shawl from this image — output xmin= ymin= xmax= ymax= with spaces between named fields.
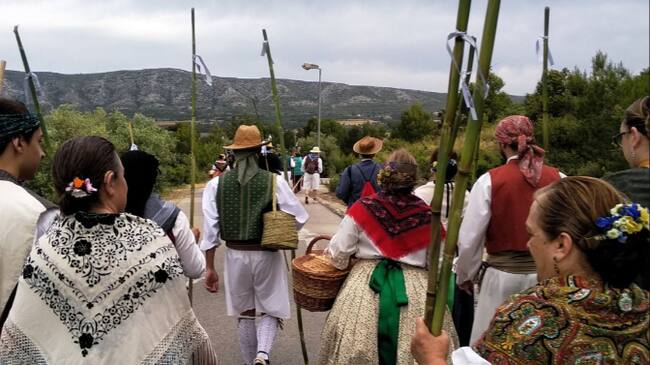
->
xmin=412 ymin=176 xmax=650 ymax=365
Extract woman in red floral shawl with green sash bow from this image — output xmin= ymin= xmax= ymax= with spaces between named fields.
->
xmin=318 ymin=149 xmax=457 ymax=365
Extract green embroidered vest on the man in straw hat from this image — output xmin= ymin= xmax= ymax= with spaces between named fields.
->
xmin=216 ymin=170 xmax=275 ymax=244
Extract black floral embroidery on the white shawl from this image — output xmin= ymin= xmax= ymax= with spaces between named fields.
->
xmin=22 ymin=214 xmax=183 ymax=356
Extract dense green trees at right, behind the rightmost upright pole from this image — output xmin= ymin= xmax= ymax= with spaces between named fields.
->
xmin=525 ymin=52 xmax=650 ymax=177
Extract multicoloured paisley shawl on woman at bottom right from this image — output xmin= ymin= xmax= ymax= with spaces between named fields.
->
xmin=474 ymin=277 xmax=650 ymax=365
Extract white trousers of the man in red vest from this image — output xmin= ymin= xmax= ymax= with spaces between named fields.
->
xmin=469 ymin=267 xmax=537 ymax=345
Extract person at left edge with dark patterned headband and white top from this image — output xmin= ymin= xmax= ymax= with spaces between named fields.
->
xmin=0 ymin=98 xmax=57 ymax=330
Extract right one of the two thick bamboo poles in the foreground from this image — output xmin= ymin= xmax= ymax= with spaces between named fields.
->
xmin=431 ymin=0 xmax=501 ymax=336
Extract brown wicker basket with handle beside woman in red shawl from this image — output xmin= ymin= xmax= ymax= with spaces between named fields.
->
xmin=291 ymin=236 xmax=350 ymax=312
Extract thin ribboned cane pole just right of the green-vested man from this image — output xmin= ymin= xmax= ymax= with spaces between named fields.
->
xmin=262 ymin=29 xmax=309 ymax=365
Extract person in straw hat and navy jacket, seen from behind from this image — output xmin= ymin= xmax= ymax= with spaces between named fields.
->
xmin=336 ymin=136 xmax=384 ymax=207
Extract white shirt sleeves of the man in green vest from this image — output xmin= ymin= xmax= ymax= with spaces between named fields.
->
xmin=201 ymin=175 xmax=309 ymax=251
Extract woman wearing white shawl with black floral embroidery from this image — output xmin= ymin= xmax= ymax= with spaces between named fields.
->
xmin=0 ymin=136 xmax=217 ymax=365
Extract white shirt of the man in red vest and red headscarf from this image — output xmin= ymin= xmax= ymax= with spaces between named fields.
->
xmin=455 ymin=156 xmax=566 ymax=284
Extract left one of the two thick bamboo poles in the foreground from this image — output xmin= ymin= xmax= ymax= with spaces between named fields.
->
xmin=424 ymin=0 xmax=472 ymax=326
